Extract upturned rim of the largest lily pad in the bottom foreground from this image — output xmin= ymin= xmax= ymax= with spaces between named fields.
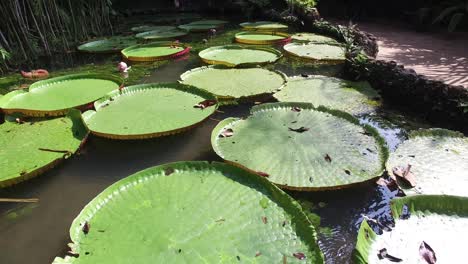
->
xmin=53 ymin=161 xmax=324 ymax=264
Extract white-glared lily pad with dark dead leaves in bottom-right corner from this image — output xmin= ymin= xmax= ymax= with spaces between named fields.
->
xmin=354 ymin=195 xmax=468 ymax=264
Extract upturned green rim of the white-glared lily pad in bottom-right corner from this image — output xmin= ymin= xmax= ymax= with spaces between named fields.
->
xmin=353 ymin=195 xmax=468 ymax=264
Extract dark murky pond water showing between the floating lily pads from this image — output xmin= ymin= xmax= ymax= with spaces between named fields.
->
xmin=0 ymin=15 xmax=434 ymax=264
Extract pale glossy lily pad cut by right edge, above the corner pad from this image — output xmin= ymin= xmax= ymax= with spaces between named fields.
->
xmin=387 ymin=129 xmax=468 ymax=196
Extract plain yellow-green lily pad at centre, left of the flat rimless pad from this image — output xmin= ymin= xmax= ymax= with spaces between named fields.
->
xmin=180 ymin=66 xmax=286 ymax=99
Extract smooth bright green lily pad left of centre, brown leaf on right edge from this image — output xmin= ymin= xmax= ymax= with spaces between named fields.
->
xmin=83 ymin=83 xmax=217 ymax=139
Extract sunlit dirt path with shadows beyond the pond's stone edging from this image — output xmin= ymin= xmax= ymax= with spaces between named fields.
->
xmin=358 ymin=23 xmax=468 ymax=88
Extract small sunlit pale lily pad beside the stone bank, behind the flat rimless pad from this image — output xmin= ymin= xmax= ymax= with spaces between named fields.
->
xmin=284 ymin=43 xmax=346 ymax=62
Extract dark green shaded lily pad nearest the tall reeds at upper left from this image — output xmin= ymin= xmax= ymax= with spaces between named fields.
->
xmin=78 ymin=36 xmax=137 ymax=53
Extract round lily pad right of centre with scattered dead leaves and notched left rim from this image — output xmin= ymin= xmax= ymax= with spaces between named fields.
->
xmin=211 ymin=103 xmax=387 ymax=190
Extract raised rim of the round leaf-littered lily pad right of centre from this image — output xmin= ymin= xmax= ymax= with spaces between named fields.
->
xmin=211 ymin=102 xmax=389 ymax=191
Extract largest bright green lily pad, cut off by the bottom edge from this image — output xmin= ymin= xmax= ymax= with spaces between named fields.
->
xmin=54 ymin=162 xmax=324 ymax=264
